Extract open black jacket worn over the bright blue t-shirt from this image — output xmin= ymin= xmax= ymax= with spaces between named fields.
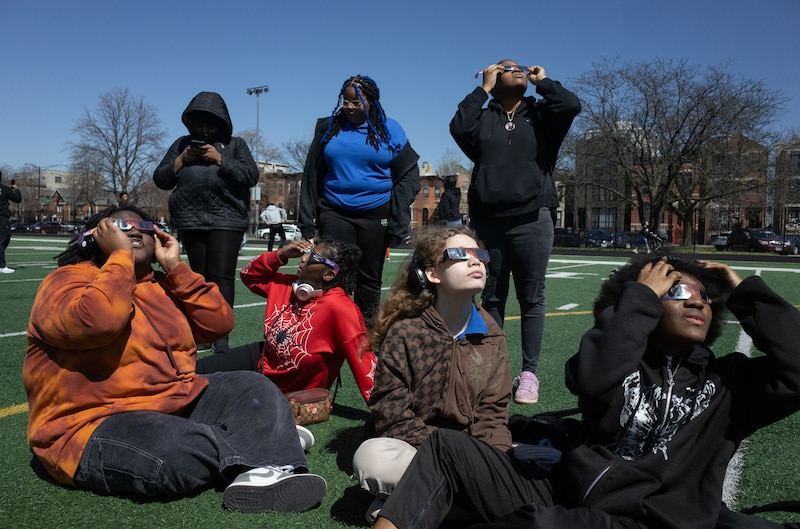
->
xmin=298 ymin=117 xmax=422 ymax=246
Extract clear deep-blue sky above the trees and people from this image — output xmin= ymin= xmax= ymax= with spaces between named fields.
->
xmin=0 ymin=0 xmax=800 ymax=169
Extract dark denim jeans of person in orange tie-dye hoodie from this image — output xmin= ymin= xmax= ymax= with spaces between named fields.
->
xmin=75 ymin=371 xmax=307 ymax=496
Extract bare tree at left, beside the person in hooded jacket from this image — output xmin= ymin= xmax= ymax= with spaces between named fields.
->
xmin=70 ymin=88 xmax=165 ymax=204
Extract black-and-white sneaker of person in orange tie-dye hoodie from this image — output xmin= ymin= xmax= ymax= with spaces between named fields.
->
xmin=223 ymin=467 xmax=328 ymax=512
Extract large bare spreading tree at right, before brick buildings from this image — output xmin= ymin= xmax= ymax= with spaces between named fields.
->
xmin=575 ymin=59 xmax=786 ymax=240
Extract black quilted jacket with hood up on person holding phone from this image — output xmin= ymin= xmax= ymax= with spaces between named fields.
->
xmin=153 ymin=92 xmax=258 ymax=231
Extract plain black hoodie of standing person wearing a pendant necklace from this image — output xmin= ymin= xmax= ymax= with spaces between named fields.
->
xmin=450 ymin=78 xmax=581 ymax=218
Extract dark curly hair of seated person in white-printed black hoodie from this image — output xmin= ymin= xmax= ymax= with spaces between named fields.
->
xmin=592 ymin=251 xmax=730 ymax=345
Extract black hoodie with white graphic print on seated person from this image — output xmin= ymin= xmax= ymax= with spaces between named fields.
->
xmin=551 ymin=276 xmax=800 ymax=529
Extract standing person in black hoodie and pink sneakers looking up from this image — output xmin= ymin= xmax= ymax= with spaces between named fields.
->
xmin=450 ymin=60 xmax=581 ymax=404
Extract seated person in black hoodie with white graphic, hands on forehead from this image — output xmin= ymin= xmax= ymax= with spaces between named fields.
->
xmin=375 ymin=255 xmax=800 ymax=529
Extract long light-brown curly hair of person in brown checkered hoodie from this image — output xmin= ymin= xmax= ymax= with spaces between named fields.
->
xmin=370 ymin=226 xmax=482 ymax=351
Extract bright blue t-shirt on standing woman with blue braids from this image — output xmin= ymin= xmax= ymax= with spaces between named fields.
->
xmin=323 ymin=118 xmax=408 ymax=211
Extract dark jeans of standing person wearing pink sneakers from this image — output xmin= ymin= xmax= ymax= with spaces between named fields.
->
xmin=471 ymin=208 xmax=553 ymax=373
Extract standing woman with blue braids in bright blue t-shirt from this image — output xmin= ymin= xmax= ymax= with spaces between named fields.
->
xmin=299 ymin=75 xmax=420 ymax=323
